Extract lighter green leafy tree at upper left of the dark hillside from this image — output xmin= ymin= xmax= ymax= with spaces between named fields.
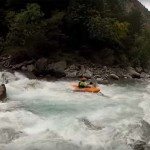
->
xmin=6 ymin=4 xmax=44 ymax=46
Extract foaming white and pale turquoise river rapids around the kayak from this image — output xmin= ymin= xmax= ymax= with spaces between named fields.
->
xmin=0 ymin=72 xmax=150 ymax=150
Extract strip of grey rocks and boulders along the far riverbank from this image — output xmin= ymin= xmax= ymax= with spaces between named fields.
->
xmin=0 ymin=56 xmax=150 ymax=84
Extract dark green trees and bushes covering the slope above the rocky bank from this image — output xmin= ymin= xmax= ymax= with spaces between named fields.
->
xmin=0 ymin=0 xmax=150 ymax=67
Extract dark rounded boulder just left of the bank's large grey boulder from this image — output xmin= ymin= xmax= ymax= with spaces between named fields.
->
xmin=35 ymin=57 xmax=48 ymax=72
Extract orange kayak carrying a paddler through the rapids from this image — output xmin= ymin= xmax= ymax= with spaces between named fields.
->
xmin=72 ymin=84 xmax=100 ymax=93
